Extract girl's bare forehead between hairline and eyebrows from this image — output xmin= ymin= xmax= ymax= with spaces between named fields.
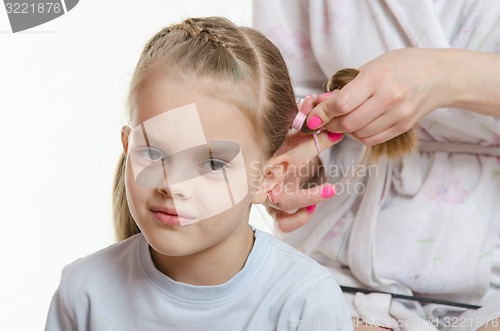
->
xmin=131 ymin=78 xmax=255 ymax=147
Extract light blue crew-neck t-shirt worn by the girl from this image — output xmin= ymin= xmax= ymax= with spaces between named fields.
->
xmin=45 ymin=230 xmax=352 ymax=331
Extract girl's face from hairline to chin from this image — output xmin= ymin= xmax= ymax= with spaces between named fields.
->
xmin=122 ymin=78 xmax=274 ymax=256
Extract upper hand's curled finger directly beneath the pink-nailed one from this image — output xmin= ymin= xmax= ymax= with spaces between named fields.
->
xmin=324 ymin=97 xmax=386 ymax=134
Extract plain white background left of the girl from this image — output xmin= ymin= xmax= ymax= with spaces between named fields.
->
xmin=0 ymin=0 xmax=278 ymax=331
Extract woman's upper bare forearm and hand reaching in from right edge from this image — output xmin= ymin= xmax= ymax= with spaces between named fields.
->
xmin=307 ymin=48 xmax=500 ymax=146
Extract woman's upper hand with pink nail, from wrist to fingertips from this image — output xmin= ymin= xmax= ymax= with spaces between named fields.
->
xmin=307 ymin=48 xmax=452 ymax=146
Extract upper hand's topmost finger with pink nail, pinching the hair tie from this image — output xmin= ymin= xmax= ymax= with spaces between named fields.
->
xmin=307 ymin=76 xmax=373 ymax=129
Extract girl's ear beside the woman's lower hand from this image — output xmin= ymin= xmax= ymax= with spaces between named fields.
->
xmin=253 ymin=154 xmax=290 ymax=203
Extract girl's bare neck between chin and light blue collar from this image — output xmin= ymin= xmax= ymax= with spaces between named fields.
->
xmin=151 ymin=223 xmax=254 ymax=286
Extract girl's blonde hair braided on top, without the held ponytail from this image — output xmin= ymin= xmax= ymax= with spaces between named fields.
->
xmin=113 ymin=17 xmax=297 ymax=240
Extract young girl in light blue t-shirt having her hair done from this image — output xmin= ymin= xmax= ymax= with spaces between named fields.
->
xmin=46 ymin=18 xmax=352 ymax=331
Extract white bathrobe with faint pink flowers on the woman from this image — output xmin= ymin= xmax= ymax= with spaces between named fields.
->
xmin=254 ymin=0 xmax=500 ymax=330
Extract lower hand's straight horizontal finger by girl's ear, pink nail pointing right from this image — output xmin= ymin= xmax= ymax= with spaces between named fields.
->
xmin=273 ymin=183 xmax=335 ymax=211
